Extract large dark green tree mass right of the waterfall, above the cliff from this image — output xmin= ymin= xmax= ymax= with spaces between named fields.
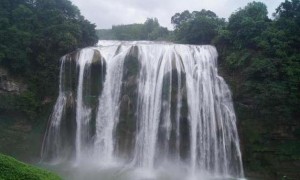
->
xmin=216 ymin=1 xmax=300 ymax=121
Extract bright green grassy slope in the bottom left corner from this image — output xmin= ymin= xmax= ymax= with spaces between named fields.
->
xmin=0 ymin=154 xmax=61 ymax=180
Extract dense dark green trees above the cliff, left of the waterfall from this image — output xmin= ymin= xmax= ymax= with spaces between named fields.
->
xmin=0 ymin=0 xmax=97 ymax=98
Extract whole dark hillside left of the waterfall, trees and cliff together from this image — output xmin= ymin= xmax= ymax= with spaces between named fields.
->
xmin=0 ymin=0 xmax=98 ymax=159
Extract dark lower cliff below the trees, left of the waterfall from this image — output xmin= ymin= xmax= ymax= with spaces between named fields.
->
xmin=0 ymin=67 xmax=52 ymax=161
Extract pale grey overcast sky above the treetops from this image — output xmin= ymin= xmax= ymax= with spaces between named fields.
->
xmin=71 ymin=0 xmax=284 ymax=29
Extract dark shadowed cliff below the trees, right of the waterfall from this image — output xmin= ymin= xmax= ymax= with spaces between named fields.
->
xmin=220 ymin=64 xmax=300 ymax=180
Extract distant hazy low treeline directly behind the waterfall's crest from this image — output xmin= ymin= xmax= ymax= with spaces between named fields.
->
xmin=97 ymin=18 xmax=169 ymax=40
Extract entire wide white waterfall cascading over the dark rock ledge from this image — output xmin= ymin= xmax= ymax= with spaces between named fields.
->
xmin=42 ymin=41 xmax=244 ymax=180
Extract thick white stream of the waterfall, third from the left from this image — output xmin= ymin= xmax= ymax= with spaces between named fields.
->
xmin=94 ymin=46 xmax=130 ymax=163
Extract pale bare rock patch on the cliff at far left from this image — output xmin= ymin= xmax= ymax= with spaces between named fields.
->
xmin=0 ymin=67 xmax=27 ymax=94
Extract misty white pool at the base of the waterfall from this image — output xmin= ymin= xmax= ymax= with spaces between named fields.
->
xmin=42 ymin=162 xmax=246 ymax=180
